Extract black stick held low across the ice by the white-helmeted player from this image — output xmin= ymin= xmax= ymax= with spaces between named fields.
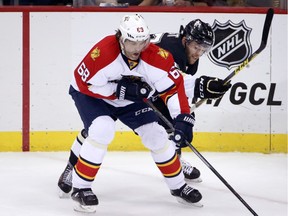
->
xmin=144 ymin=100 xmax=258 ymax=216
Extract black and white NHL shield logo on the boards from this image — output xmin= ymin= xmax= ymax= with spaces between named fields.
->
xmin=208 ymin=20 xmax=252 ymax=70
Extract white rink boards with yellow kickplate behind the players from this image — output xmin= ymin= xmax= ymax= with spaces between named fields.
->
xmin=0 ymin=8 xmax=288 ymax=153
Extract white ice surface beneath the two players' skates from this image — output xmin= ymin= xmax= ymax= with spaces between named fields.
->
xmin=0 ymin=152 xmax=287 ymax=216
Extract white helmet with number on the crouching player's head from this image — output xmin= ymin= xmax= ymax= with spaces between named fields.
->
xmin=119 ymin=14 xmax=150 ymax=42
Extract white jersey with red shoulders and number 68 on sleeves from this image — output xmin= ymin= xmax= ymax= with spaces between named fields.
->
xmin=71 ymin=35 xmax=190 ymax=118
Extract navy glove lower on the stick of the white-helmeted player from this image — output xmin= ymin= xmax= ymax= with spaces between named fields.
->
xmin=173 ymin=114 xmax=195 ymax=148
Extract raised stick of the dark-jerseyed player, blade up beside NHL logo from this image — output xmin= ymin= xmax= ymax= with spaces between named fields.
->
xmin=190 ymin=8 xmax=274 ymax=112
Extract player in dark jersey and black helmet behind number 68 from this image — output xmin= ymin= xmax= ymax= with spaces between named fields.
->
xmin=58 ymin=19 xmax=230 ymax=206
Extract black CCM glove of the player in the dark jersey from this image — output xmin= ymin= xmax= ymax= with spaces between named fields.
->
xmin=194 ymin=76 xmax=231 ymax=99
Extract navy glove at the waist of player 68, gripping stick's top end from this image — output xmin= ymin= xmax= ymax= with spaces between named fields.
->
xmin=116 ymin=77 xmax=152 ymax=102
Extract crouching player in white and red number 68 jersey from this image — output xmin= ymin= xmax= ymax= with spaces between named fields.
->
xmin=63 ymin=14 xmax=202 ymax=212
